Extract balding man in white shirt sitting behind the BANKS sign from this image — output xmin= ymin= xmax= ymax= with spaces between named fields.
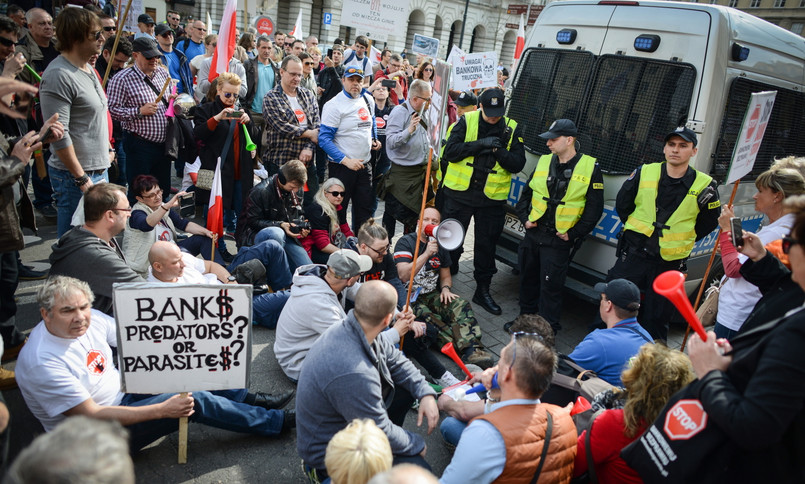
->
xmin=147 ymin=240 xmax=291 ymax=329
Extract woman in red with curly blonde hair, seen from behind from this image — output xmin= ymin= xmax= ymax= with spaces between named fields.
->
xmin=573 ymin=343 xmax=696 ymax=484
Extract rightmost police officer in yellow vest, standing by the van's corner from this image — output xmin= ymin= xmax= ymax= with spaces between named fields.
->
xmin=607 ymin=127 xmax=721 ymax=340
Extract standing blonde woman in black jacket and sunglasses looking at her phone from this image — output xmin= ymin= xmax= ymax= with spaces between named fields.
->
xmin=193 ymin=72 xmax=257 ymax=232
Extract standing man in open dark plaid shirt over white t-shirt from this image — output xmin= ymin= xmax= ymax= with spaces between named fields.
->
xmin=263 ymin=55 xmax=319 ymax=203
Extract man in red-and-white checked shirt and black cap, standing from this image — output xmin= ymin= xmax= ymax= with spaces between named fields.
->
xmin=107 ymin=37 xmax=171 ymax=198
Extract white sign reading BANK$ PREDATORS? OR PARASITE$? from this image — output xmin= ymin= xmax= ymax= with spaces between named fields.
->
xmin=114 ymin=283 xmax=252 ymax=393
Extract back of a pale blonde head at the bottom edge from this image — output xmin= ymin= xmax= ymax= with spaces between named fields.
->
xmin=319 ymin=418 xmax=393 ymax=484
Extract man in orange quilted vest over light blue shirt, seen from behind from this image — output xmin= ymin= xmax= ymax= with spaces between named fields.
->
xmin=439 ymin=333 xmax=577 ymax=483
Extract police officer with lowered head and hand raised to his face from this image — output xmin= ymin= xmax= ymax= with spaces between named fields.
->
xmin=442 ymin=88 xmax=525 ymax=315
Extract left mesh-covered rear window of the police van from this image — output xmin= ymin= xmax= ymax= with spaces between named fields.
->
xmin=508 ymin=48 xmax=594 ymax=155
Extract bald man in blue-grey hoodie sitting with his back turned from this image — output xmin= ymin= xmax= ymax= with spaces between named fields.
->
xmin=296 ymin=280 xmax=436 ymax=479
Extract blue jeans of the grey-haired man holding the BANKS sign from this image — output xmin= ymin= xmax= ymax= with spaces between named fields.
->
xmin=120 ymin=389 xmax=285 ymax=451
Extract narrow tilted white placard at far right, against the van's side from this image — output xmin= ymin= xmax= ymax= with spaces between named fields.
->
xmin=727 ymin=91 xmax=777 ymax=184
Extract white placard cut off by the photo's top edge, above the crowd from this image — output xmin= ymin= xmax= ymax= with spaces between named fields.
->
xmin=341 ymin=0 xmax=408 ymax=40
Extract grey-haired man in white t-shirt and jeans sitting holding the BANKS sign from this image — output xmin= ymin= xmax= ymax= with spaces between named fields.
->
xmin=16 ymin=276 xmax=296 ymax=450
